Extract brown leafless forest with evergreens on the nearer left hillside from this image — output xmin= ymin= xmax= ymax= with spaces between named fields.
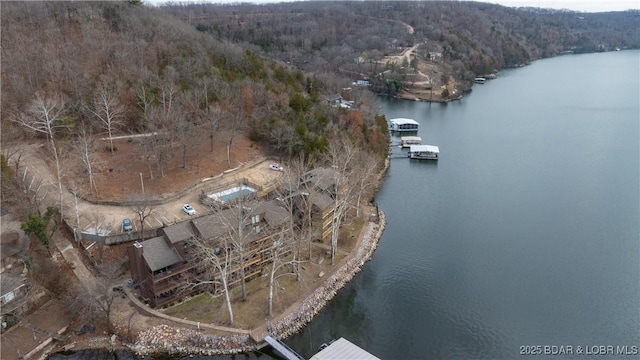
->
xmin=1 ymin=1 xmax=387 ymax=176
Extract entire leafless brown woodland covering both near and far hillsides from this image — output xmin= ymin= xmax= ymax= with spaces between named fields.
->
xmin=0 ymin=1 xmax=640 ymax=169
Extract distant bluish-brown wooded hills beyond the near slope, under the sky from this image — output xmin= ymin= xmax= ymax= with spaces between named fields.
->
xmin=163 ymin=1 xmax=640 ymax=92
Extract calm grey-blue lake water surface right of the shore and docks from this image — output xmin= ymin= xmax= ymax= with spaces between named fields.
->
xmin=286 ymin=51 xmax=640 ymax=359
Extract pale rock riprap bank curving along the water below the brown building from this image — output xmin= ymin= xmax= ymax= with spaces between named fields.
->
xmin=128 ymin=207 xmax=386 ymax=356
